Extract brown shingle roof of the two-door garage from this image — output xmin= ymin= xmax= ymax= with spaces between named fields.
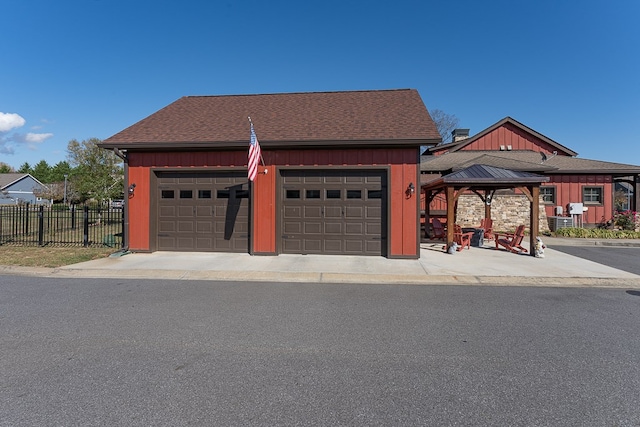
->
xmin=100 ymin=89 xmax=440 ymax=148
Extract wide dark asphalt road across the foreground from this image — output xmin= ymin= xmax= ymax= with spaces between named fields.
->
xmin=0 ymin=276 xmax=640 ymax=426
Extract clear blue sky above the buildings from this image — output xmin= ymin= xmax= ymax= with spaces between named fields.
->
xmin=0 ymin=0 xmax=640 ymax=168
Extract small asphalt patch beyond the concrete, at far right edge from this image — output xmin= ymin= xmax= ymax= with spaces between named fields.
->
xmin=553 ymin=245 xmax=640 ymax=274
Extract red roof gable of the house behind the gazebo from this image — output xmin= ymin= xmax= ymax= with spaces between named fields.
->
xmin=429 ymin=117 xmax=578 ymax=156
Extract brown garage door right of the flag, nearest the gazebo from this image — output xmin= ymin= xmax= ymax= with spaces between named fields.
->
xmin=280 ymin=170 xmax=387 ymax=255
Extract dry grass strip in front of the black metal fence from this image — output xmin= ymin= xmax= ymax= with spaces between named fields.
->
xmin=0 ymin=245 xmax=118 ymax=268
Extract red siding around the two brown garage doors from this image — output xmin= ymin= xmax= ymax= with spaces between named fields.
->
xmin=127 ymin=148 xmax=419 ymax=257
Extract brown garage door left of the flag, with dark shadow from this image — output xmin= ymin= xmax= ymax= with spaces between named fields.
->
xmin=156 ymin=172 xmax=249 ymax=252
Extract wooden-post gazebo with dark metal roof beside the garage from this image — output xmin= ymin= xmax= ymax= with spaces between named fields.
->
xmin=422 ymin=164 xmax=549 ymax=255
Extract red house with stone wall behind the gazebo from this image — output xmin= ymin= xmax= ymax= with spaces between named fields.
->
xmin=420 ymin=117 xmax=640 ymax=231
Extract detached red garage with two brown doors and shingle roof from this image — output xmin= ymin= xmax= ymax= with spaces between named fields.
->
xmin=100 ymin=89 xmax=440 ymax=258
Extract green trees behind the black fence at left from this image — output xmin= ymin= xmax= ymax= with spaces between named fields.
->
xmin=0 ymin=138 xmax=124 ymax=203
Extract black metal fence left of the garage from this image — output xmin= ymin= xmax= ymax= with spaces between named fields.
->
xmin=0 ymin=204 xmax=124 ymax=248
